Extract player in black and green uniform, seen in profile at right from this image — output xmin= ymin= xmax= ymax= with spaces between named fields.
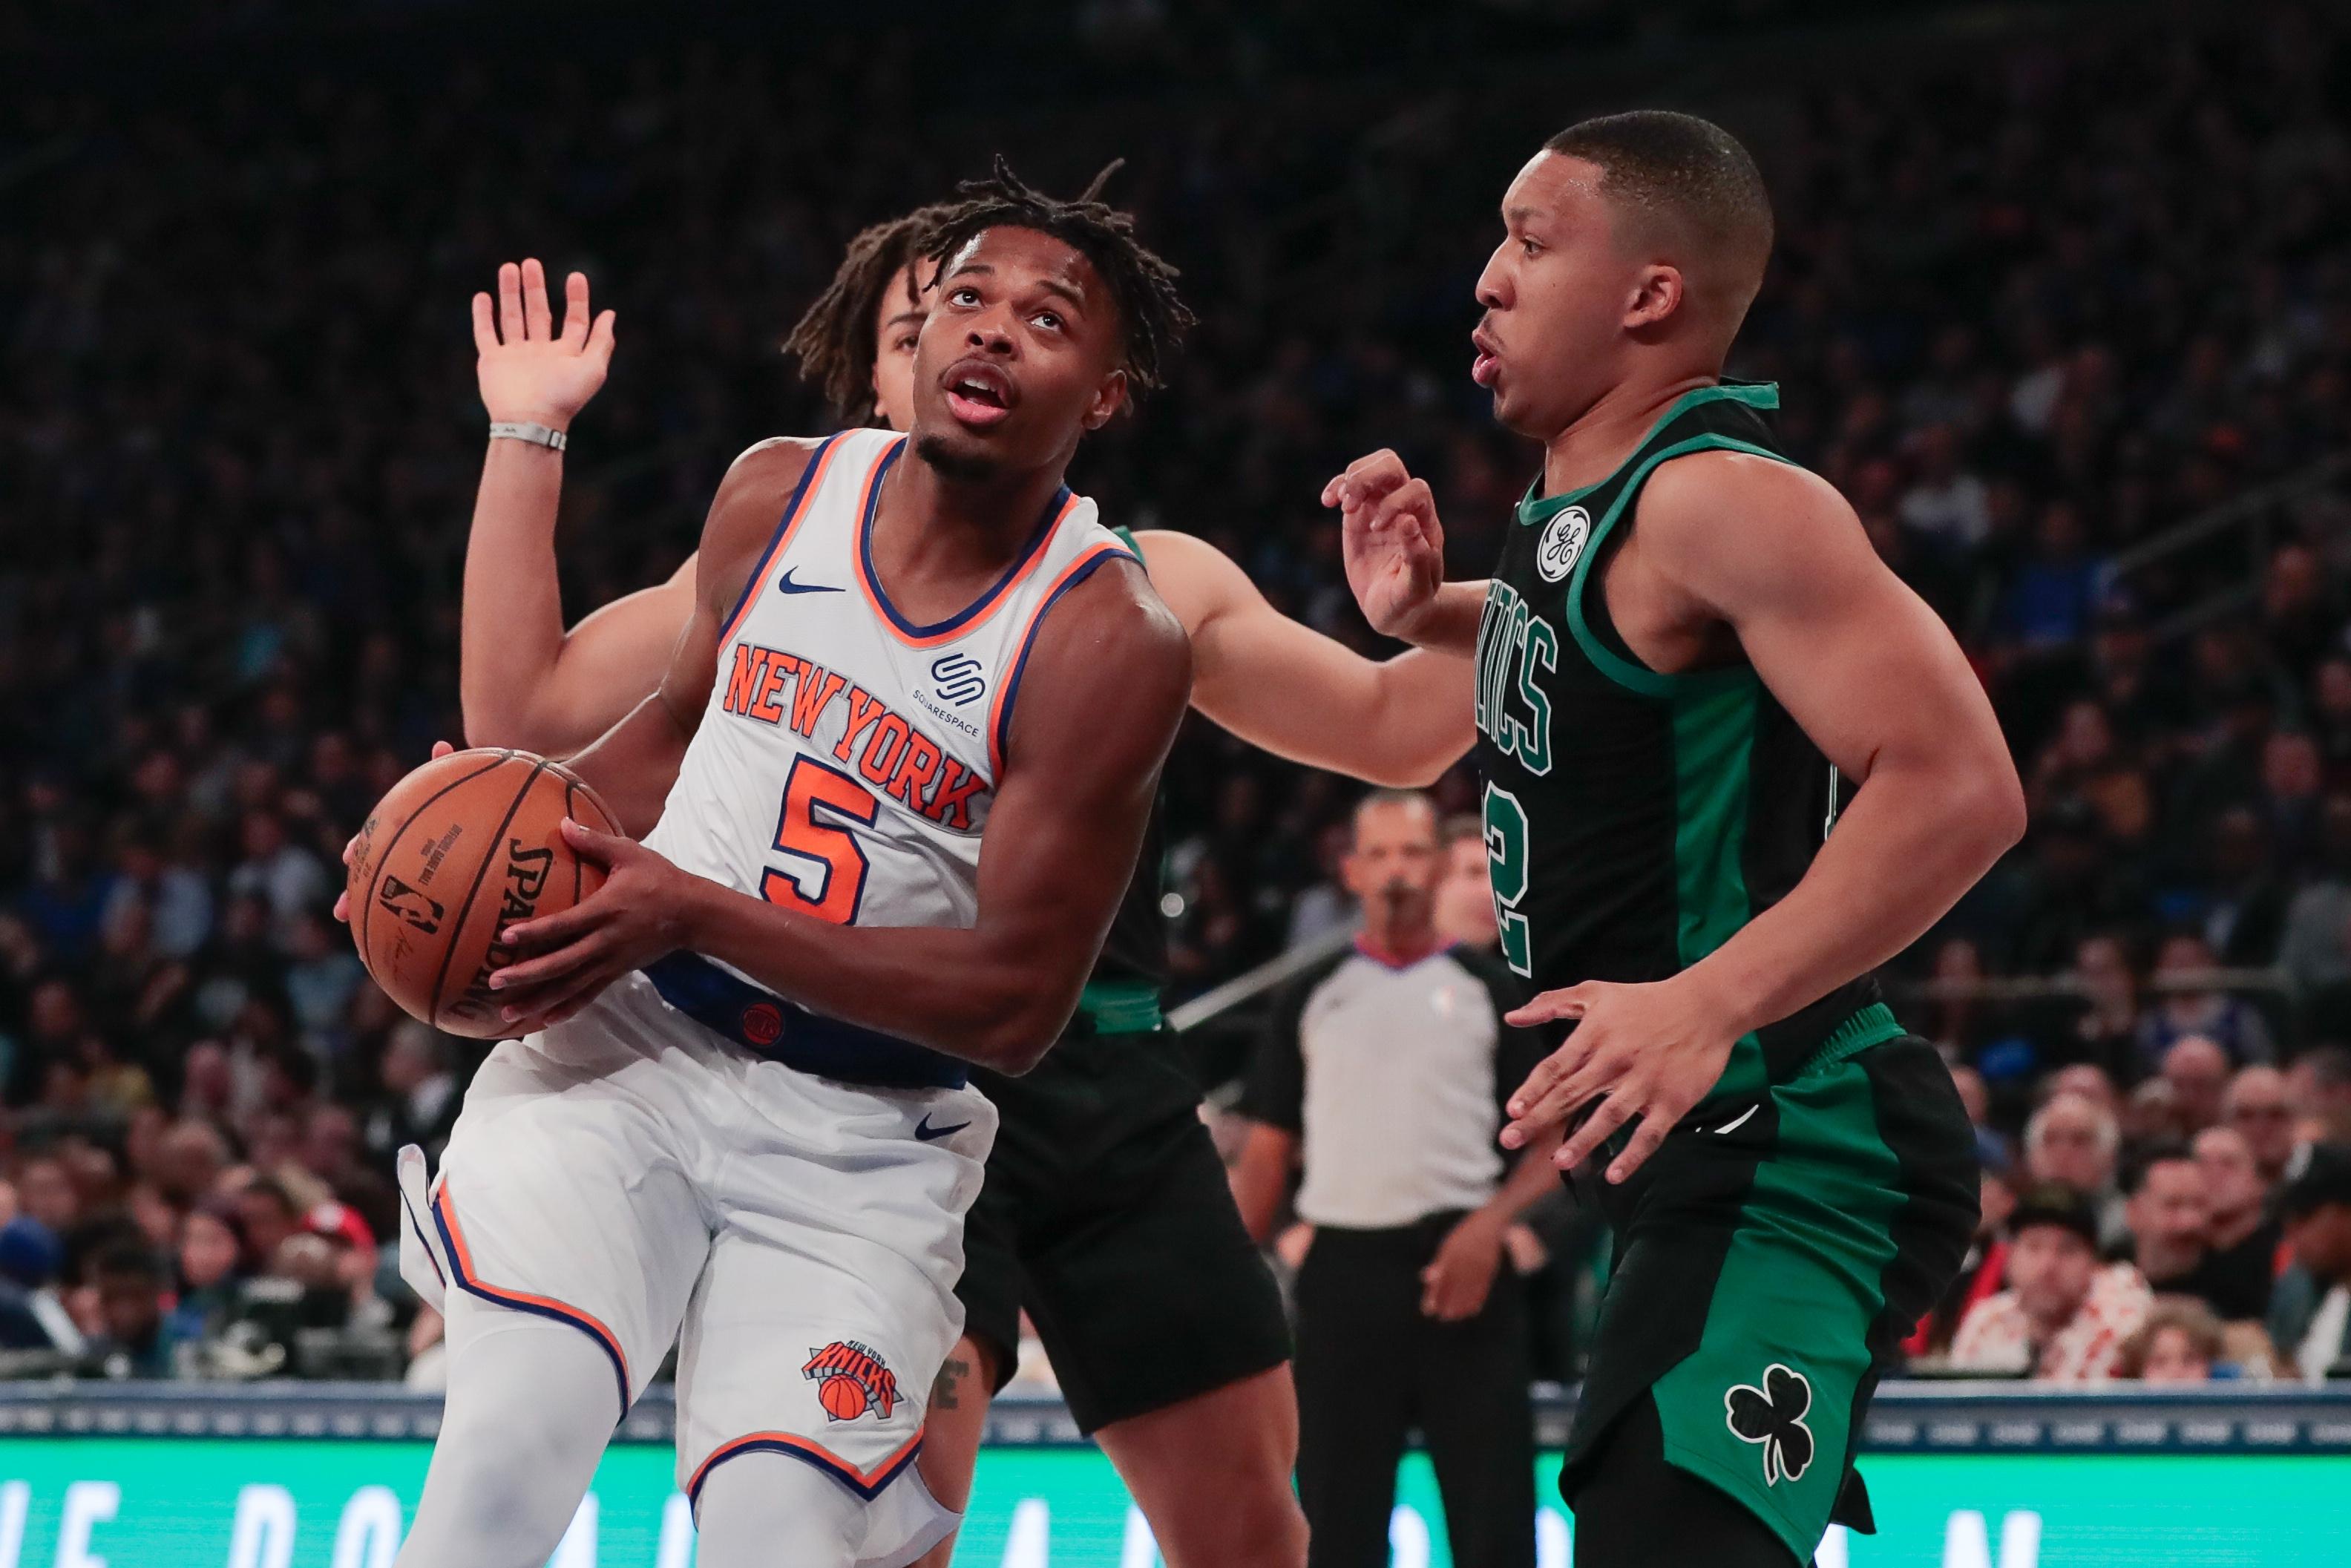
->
xmin=1324 ymin=113 xmax=2024 ymax=1568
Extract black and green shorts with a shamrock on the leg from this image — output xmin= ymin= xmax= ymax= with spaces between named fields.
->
xmin=1558 ymin=1037 xmax=1977 ymax=1561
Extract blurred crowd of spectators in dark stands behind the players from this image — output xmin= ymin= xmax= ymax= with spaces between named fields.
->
xmin=0 ymin=4 xmax=2351 ymax=1375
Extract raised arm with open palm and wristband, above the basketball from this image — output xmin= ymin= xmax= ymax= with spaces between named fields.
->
xmin=459 ymin=261 xmax=694 ymax=755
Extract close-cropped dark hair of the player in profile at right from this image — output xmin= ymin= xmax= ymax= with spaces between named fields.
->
xmin=1542 ymin=108 xmax=1773 ymax=296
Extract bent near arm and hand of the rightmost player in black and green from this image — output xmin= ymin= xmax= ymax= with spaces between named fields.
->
xmin=1502 ymin=453 xmax=2024 ymax=1180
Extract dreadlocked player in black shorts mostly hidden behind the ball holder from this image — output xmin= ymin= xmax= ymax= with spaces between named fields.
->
xmin=449 ymin=165 xmax=1500 ymax=1568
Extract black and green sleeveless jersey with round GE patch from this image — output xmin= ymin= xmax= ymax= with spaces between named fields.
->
xmin=1477 ymin=383 xmax=1898 ymax=1093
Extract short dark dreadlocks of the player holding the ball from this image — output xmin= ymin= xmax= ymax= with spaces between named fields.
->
xmin=922 ymin=153 xmax=1194 ymax=395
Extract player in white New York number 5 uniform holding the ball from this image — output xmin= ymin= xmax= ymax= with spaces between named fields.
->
xmin=400 ymin=171 xmax=1190 ymax=1568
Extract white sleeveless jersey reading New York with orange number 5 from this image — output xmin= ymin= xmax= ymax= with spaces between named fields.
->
xmin=646 ymin=430 xmax=1133 ymax=945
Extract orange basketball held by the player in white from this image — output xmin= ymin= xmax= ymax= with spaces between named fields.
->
xmin=348 ymin=750 xmax=620 ymax=1039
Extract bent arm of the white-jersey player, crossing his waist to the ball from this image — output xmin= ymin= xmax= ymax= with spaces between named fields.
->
xmin=494 ymin=548 xmax=1192 ymax=1072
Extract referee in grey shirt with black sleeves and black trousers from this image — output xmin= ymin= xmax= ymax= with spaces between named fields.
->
xmin=1234 ymin=790 xmax=1556 ymax=1568
